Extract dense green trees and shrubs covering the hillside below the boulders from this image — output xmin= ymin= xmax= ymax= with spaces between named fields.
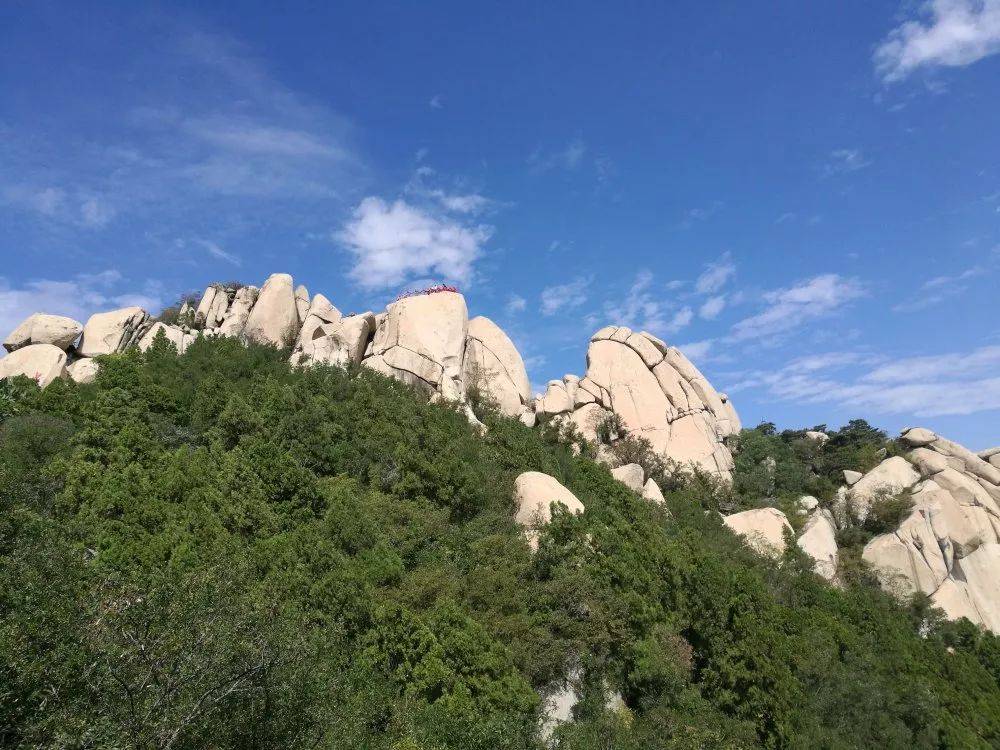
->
xmin=0 ymin=336 xmax=1000 ymax=750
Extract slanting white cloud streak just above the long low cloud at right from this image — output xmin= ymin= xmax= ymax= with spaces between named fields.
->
xmin=729 ymin=273 xmax=865 ymax=341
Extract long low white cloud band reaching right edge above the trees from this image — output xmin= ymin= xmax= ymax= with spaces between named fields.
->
xmin=728 ymin=346 xmax=1000 ymax=417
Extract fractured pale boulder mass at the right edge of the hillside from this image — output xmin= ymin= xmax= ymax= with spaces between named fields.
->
xmin=846 ymin=428 xmax=1000 ymax=633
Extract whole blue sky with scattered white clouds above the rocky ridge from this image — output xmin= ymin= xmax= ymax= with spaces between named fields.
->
xmin=0 ymin=0 xmax=1000 ymax=448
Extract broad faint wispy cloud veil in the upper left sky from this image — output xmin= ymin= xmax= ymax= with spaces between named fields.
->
xmin=0 ymin=15 xmax=365 ymax=246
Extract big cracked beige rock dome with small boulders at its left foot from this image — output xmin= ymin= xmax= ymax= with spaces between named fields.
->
xmin=535 ymin=326 xmax=741 ymax=478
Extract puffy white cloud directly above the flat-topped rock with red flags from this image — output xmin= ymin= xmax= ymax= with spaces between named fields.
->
xmin=335 ymin=196 xmax=493 ymax=289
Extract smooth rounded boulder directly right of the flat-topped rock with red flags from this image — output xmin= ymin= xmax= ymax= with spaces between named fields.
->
xmin=462 ymin=316 xmax=531 ymax=417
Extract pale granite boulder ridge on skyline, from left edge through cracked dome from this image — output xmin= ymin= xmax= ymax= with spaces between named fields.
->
xmin=0 ymin=274 xmax=740 ymax=478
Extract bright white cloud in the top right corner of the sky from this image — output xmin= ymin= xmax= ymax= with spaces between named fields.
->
xmin=874 ymin=0 xmax=1000 ymax=83
